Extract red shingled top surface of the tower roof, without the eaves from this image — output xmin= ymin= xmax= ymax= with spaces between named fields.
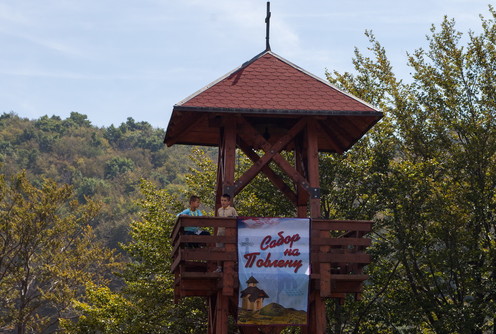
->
xmin=175 ymin=51 xmax=378 ymax=113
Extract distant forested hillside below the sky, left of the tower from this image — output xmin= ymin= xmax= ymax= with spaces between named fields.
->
xmin=0 ymin=112 xmax=202 ymax=247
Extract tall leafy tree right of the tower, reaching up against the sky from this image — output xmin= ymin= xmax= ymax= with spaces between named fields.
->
xmin=325 ymin=7 xmax=496 ymax=333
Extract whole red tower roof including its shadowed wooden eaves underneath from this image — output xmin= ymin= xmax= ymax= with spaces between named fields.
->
xmin=164 ymin=51 xmax=382 ymax=153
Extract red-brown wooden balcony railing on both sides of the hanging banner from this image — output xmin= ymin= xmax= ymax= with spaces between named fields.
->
xmin=171 ymin=216 xmax=372 ymax=299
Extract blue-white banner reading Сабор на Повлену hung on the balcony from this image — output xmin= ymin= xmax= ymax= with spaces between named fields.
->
xmin=237 ymin=218 xmax=310 ymax=326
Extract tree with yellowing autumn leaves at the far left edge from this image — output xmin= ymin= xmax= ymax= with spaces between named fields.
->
xmin=0 ymin=173 xmax=118 ymax=334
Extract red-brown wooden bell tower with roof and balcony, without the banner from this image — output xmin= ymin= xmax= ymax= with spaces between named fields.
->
xmin=164 ymin=2 xmax=382 ymax=334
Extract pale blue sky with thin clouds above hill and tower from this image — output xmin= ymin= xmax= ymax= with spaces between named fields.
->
xmin=0 ymin=0 xmax=491 ymax=128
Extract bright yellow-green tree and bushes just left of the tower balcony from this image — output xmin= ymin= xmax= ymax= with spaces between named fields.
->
xmin=64 ymin=181 xmax=206 ymax=334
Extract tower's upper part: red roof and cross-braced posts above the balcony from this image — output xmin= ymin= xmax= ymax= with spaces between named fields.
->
xmin=165 ymin=50 xmax=382 ymax=217
